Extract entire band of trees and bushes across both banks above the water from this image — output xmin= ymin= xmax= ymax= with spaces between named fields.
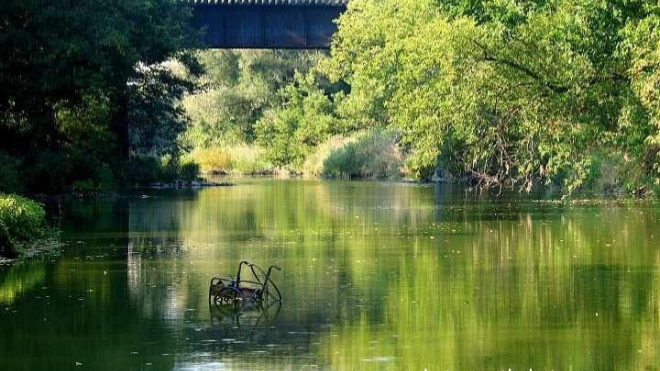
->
xmin=0 ymin=0 xmax=660 ymax=193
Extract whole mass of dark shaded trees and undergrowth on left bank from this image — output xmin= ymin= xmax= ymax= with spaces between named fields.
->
xmin=0 ymin=0 xmax=200 ymax=193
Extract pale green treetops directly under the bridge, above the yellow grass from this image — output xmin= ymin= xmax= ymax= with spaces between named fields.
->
xmin=183 ymin=50 xmax=322 ymax=148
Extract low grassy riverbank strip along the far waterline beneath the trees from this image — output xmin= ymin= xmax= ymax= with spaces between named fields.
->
xmin=183 ymin=143 xmax=658 ymax=198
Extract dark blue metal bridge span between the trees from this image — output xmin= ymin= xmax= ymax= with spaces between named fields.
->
xmin=184 ymin=0 xmax=349 ymax=49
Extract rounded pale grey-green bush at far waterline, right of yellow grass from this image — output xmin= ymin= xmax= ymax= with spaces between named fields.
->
xmin=305 ymin=130 xmax=403 ymax=179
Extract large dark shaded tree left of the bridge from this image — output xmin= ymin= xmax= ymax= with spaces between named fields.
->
xmin=0 ymin=0 xmax=199 ymax=191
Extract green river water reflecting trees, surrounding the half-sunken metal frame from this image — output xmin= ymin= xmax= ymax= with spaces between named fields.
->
xmin=0 ymin=179 xmax=660 ymax=371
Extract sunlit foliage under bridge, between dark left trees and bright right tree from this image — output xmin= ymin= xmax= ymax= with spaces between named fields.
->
xmin=180 ymin=50 xmax=329 ymax=178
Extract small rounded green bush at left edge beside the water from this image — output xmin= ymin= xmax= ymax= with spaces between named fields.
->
xmin=0 ymin=195 xmax=46 ymax=241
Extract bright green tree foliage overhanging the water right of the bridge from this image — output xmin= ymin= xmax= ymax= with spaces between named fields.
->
xmin=257 ymin=0 xmax=660 ymax=192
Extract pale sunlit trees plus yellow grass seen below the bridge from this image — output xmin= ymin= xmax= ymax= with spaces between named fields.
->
xmin=181 ymin=50 xmax=323 ymax=174
